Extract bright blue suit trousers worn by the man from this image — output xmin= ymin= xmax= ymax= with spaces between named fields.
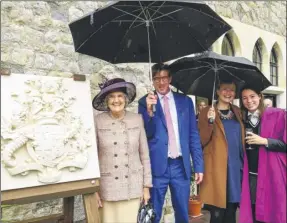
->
xmin=151 ymin=157 xmax=190 ymax=223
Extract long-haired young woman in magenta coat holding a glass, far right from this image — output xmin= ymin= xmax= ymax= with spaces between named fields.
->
xmin=240 ymin=86 xmax=287 ymax=223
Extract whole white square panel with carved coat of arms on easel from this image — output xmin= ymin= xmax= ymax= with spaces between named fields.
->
xmin=1 ymin=74 xmax=100 ymax=191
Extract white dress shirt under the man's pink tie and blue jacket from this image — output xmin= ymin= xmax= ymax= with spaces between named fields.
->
xmin=157 ymin=90 xmax=182 ymax=157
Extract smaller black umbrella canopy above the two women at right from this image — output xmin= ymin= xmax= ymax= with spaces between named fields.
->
xmin=170 ymin=51 xmax=272 ymax=99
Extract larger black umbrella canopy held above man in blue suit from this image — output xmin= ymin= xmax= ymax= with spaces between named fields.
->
xmin=69 ymin=1 xmax=231 ymax=63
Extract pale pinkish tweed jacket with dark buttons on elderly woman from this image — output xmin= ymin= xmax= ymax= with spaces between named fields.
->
xmin=95 ymin=111 xmax=152 ymax=201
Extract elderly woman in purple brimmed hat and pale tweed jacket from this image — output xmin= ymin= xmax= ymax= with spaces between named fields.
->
xmin=93 ymin=78 xmax=152 ymax=223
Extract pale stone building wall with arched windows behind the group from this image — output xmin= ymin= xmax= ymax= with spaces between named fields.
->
xmin=1 ymin=1 xmax=286 ymax=222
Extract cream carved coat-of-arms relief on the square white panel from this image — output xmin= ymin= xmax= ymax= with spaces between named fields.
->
xmin=1 ymin=75 xmax=98 ymax=190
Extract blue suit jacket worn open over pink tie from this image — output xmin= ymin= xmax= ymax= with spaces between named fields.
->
xmin=138 ymin=92 xmax=204 ymax=178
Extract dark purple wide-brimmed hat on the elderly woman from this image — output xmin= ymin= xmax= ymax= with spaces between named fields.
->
xmin=93 ymin=78 xmax=136 ymax=111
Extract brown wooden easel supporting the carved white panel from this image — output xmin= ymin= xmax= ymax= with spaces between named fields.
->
xmin=1 ymin=179 xmax=101 ymax=223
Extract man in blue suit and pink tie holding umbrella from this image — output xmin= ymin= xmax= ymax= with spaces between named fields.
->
xmin=139 ymin=64 xmax=204 ymax=223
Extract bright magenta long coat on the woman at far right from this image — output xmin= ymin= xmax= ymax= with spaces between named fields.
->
xmin=239 ymin=108 xmax=287 ymax=223
